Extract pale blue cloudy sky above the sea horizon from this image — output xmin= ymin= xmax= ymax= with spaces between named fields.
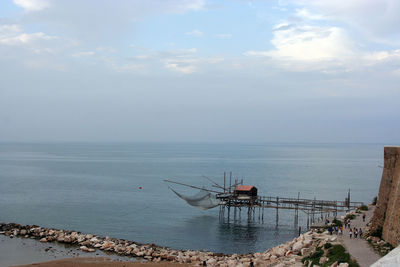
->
xmin=0 ymin=0 xmax=400 ymax=144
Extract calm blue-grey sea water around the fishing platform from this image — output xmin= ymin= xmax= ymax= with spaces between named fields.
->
xmin=0 ymin=143 xmax=383 ymax=253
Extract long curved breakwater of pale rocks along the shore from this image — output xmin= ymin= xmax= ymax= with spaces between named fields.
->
xmin=0 ymin=223 xmax=350 ymax=267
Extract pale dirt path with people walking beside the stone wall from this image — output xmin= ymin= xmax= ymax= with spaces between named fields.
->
xmin=338 ymin=207 xmax=381 ymax=267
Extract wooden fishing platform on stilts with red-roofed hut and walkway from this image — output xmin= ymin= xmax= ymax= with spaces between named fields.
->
xmin=165 ymin=172 xmax=363 ymax=228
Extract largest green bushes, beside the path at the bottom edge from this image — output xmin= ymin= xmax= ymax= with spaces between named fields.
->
xmin=302 ymin=246 xmax=360 ymax=267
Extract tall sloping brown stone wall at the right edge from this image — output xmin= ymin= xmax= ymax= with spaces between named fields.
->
xmin=371 ymin=147 xmax=400 ymax=246
